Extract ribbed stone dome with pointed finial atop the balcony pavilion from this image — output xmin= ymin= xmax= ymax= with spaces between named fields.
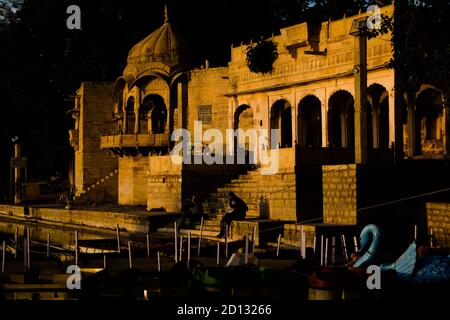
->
xmin=128 ymin=7 xmax=185 ymax=67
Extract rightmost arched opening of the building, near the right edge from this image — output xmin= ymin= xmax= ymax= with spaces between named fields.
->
xmin=415 ymin=87 xmax=445 ymax=155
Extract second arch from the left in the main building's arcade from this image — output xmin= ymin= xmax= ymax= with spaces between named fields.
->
xmin=270 ymin=99 xmax=292 ymax=148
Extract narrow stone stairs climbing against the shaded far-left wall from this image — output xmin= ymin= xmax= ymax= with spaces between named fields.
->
xmin=75 ymin=169 xmax=119 ymax=203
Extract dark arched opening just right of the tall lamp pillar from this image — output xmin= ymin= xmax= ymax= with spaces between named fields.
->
xmin=367 ymin=83 xmax=389 ymax=149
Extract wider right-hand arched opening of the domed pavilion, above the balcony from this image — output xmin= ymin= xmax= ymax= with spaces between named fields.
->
xmin=139 ymin=94 xmax=167 ymax=134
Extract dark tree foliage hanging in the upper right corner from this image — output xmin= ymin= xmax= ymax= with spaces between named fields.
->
xmin=392 ymin=0 xmax=450 ymax=92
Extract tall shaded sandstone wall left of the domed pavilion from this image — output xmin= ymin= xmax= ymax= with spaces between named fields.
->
xmin=75 ymin=82 xmax=118 ymax=200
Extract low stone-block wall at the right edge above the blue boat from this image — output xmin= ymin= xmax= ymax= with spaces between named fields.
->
xmin=426 ymin=203 xmax=450 ymax=247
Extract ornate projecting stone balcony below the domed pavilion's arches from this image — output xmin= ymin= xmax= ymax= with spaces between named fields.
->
xmin=100 ymin=133 xmax=170 ymax=156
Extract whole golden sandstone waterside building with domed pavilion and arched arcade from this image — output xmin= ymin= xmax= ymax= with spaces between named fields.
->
xmin=67 ymin=6 xmax=450 ymax=246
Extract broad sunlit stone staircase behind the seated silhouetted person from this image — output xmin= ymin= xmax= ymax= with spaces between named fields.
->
xmin=158 ymin=169 xmax=295 ymax=244
